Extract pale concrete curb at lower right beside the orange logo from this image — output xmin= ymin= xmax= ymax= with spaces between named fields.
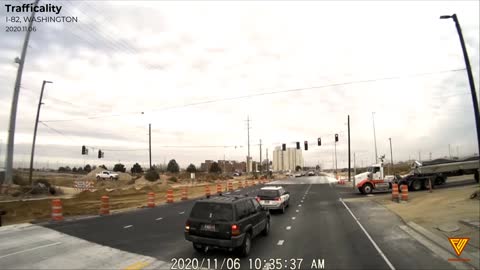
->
xmin=406 ymin=221 xmax=480 ymax=269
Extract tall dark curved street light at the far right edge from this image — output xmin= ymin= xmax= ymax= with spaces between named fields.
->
xmin=440 ymin=14 xmax=480 ymax=169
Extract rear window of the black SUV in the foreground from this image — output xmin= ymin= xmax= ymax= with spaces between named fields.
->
xmin=190 ymin=202 xmax=233 ymax=221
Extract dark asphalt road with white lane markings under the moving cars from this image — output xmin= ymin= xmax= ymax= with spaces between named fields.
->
xmin=37 ymin=176 xmax=452 ymax=269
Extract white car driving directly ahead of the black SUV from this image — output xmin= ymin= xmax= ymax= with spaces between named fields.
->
xmin=257 ymin=186 xmax=290 ymax=213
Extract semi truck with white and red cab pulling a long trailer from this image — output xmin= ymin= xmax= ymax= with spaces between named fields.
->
xmin=354 ymin=156 xmax=480 ymax=194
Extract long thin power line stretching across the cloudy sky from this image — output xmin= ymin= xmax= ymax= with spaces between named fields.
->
xmin=44 ymin=68 xmax=465 ymax=122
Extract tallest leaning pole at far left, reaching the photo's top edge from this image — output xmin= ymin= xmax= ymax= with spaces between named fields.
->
xmin=4 ymin=0 xmax=40 ymax=185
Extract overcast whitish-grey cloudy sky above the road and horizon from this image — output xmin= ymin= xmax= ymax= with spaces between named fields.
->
xmin=0 ymin=1 xmax=480 ymax=171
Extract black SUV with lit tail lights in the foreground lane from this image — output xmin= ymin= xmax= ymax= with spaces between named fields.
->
xmin=185 ymin=195 xmax=270 ymax=256
